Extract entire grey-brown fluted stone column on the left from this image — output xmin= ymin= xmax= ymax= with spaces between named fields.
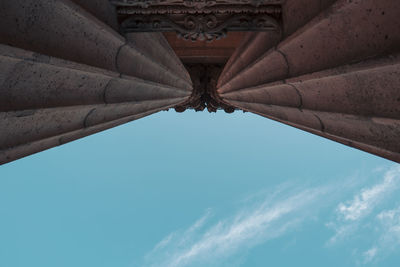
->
xmin=0 ymin=0 xmax=192 ymax=164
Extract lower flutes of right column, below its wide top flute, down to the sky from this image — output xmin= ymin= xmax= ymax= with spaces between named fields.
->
xmin=222 ymin=52 xmax=400 ymax=162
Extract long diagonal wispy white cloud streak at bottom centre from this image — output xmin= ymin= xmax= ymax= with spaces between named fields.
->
xmin=146 ymin=188 xmax=326 ymax=267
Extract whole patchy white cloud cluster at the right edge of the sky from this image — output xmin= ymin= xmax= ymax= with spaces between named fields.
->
xmin=327 ymin=165 xmax=400 ymax=264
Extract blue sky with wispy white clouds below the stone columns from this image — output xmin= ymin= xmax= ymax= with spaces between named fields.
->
xmin=0 ymin=111 xmax=400 ymax=267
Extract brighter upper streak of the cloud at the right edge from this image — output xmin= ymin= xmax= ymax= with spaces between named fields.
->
xmin=327 ymin=166 xmax=400 ymax=245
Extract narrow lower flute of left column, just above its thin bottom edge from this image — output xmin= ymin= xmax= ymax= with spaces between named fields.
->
xmin=0 ymin=98 xmax=182 ymax=153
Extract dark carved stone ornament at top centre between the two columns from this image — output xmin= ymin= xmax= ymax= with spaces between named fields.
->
xmin=111 ymin=0 xmax=282 ymax=41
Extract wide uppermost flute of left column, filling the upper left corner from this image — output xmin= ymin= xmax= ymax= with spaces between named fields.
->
xmin=0 ymin=0 xmax=191 ymax=91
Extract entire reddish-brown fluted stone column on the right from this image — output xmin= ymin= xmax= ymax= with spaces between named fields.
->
xmin=217 ymin=0 xmax=400 ymax=162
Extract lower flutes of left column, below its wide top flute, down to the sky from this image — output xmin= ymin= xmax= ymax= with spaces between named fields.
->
xmin=0 ymin=45 xmax=191 ymax=163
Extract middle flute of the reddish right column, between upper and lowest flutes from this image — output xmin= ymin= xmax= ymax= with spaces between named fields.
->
xmin=222 ymin=55 xmax=400 ymax=119
